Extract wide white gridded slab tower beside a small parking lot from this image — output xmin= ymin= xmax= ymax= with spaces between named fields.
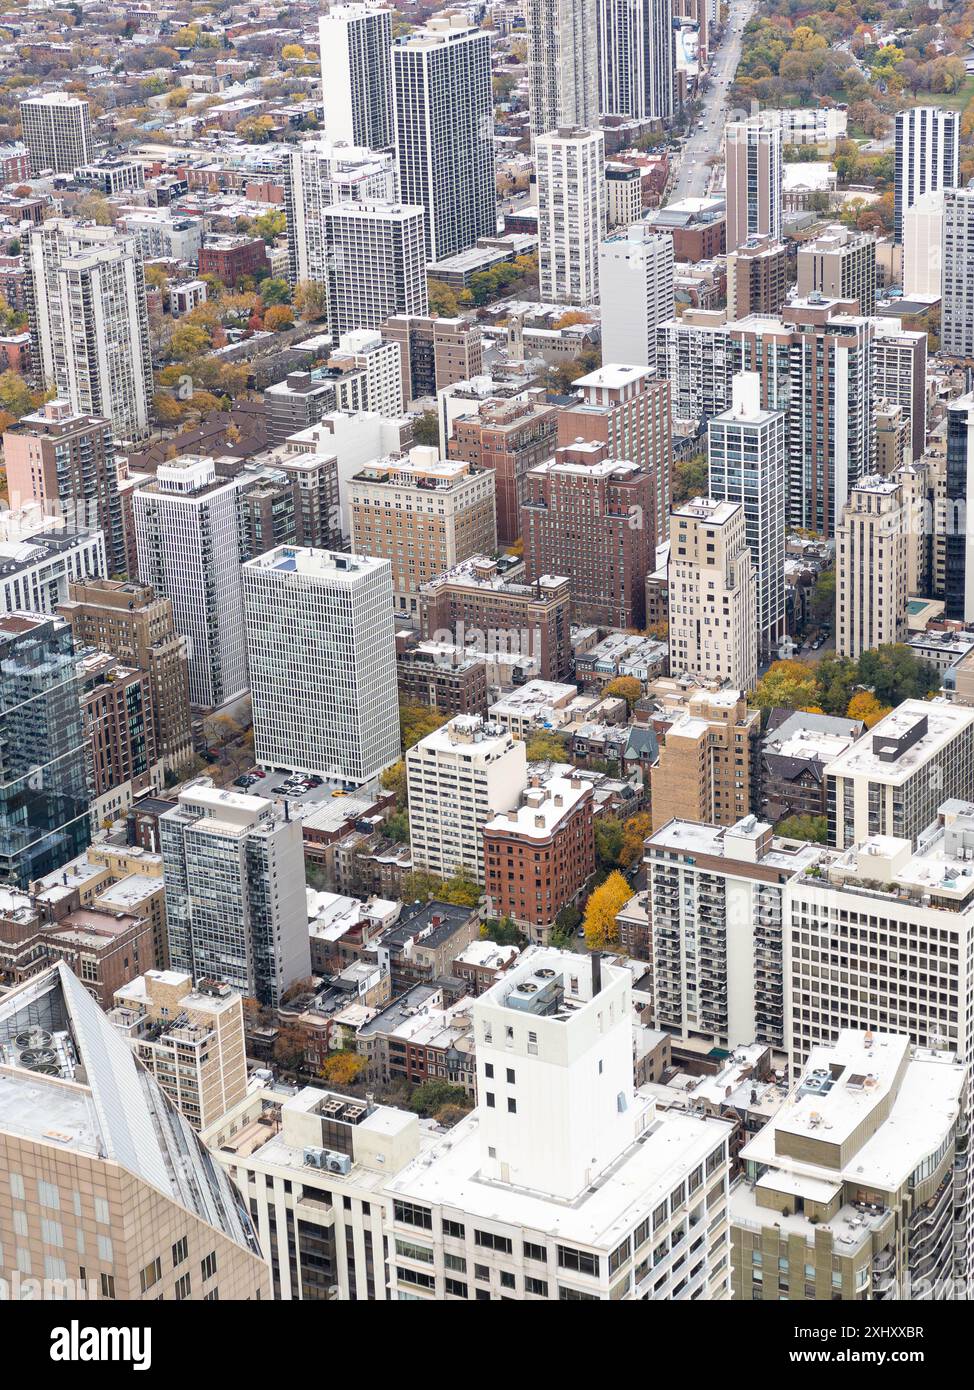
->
xmin=243 ymin=545 xmax=400 ymax=785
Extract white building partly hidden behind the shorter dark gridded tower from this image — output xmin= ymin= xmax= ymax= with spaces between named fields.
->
xmin=283 ymin=140 xmax=396 ymax=285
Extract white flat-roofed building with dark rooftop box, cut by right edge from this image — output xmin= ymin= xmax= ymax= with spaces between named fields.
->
xmin=825 ymin=699 xmax=974 ymax=849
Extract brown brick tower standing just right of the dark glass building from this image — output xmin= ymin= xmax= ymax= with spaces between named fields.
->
xmin=58 ymin=580 xmax=193 ymax=771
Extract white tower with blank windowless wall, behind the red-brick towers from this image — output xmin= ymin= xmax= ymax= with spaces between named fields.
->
xmin=599 ymin=222 xmax=677 ymax=371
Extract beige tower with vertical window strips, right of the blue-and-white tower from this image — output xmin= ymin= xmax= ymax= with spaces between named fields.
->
xmin=835 ymin=475 xmax=909 ymax=660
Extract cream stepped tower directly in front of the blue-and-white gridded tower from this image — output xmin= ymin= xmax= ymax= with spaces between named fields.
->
xmin=667 ymin=498 xmax=757 ymax=691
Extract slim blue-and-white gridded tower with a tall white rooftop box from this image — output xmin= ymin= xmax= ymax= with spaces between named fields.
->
xmin=707 ymin=371 xmax=788 ymax=658
